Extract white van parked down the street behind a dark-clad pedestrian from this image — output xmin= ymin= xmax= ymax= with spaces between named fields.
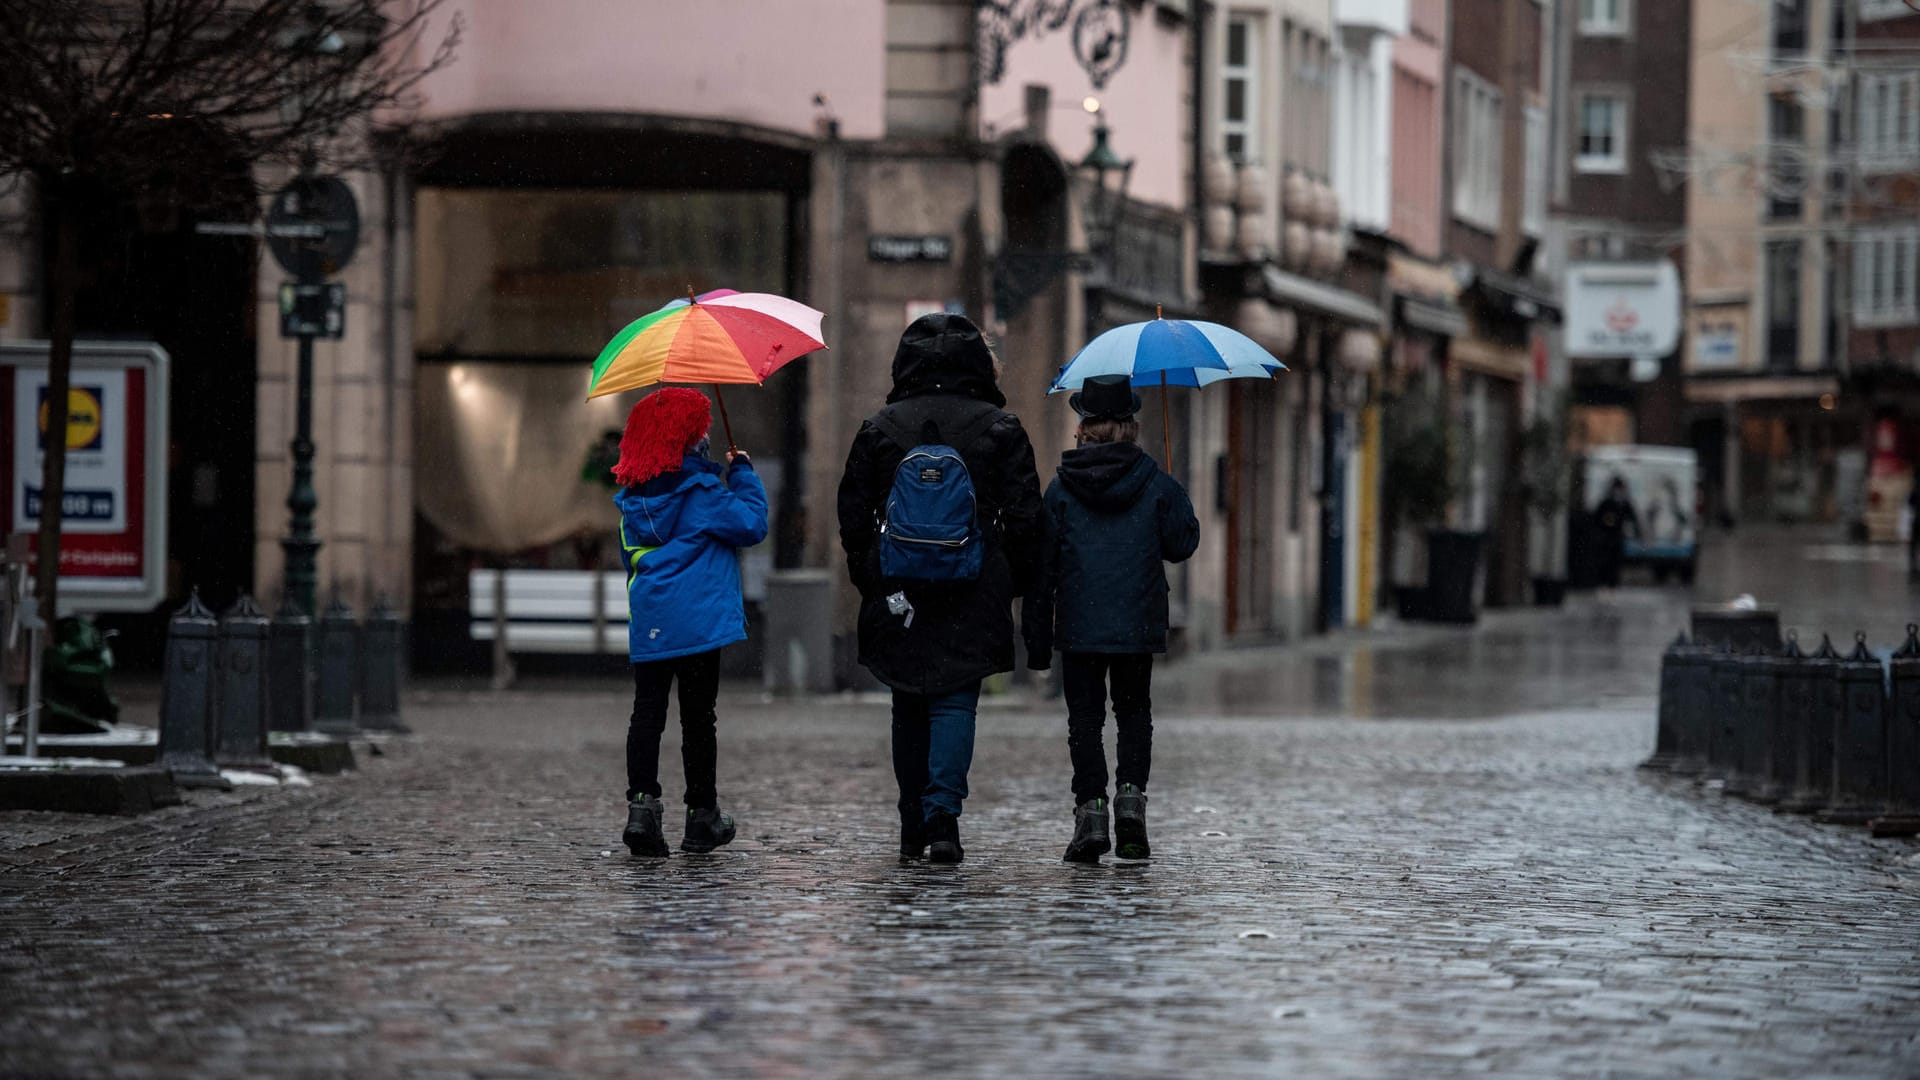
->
xmin=1584 ymin=446 xmax=1699 ymax=582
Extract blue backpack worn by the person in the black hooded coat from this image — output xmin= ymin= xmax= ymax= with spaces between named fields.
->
xmin=876 ymin=411 xmax=1000 ymax=582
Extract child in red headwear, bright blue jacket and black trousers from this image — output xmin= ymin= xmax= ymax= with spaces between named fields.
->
xmin=612 ymin=388 xmax=766 ymax=857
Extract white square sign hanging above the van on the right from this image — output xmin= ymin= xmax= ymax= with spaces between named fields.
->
xmin=1567 ymin=259 xmax=1680 ymax=357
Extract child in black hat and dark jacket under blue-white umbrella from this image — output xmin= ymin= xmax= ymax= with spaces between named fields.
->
xmin=1021 ymin=375 xmax=1200 ymax=863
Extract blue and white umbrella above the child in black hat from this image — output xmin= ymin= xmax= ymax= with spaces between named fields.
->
xmin=1046 ymin=319 xmax=1286 ymax=471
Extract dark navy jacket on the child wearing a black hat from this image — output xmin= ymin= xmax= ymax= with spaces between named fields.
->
xmin=1021 ymin=442 xmax=1200 ymax=667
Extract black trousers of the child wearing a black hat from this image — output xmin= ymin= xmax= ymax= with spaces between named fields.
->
xmin=1060 ymin=653 xmax=1154 ymax=803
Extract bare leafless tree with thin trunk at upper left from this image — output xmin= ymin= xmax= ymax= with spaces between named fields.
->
xmin=0 ymin=0 xmax=461 ymax=619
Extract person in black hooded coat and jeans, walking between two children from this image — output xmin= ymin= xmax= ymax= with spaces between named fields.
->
xmin=837 ymin=313 xmax=1041 ymax=863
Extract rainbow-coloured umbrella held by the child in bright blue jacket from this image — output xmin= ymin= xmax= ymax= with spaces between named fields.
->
xmin=588 ymin=288 xmax=828 ymax=450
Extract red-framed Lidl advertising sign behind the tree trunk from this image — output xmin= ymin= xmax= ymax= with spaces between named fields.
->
xmin=0 ymin=342 xmax=167 ymax=613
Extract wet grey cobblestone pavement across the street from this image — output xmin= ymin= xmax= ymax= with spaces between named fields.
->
xmin=0 ymin=526 xmax=1920 ymax=1076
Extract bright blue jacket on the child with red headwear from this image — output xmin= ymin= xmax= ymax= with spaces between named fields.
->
xmin=612 ymin=454 xmax=766 ymax=663
